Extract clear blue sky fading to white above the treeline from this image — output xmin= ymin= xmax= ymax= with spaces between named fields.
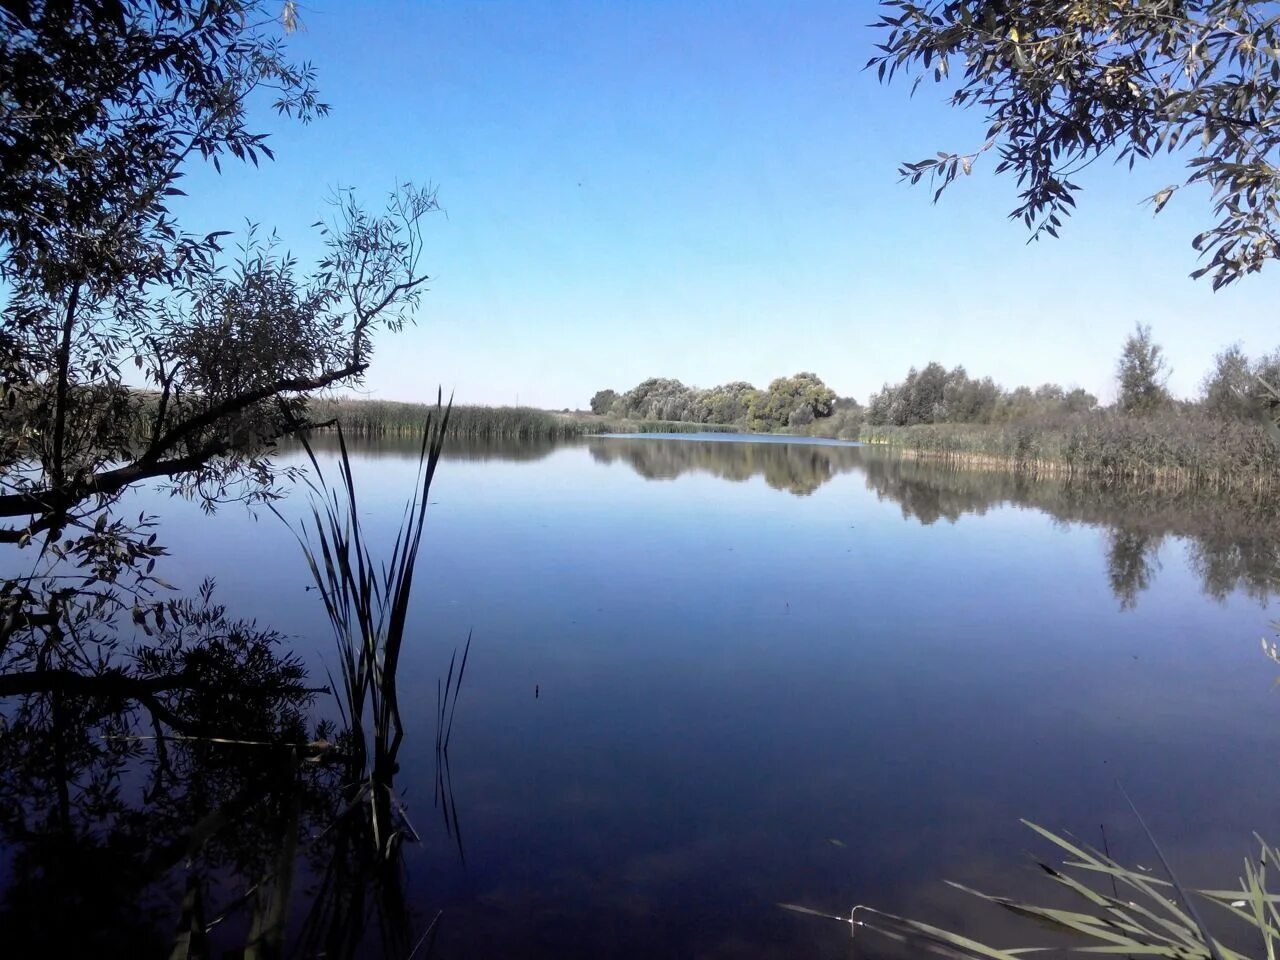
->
xmin=177 ymin=0 xmax=1280 ymax=408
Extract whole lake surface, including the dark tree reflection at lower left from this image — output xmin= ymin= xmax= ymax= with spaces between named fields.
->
xmin=0 ymin=439 xmax=1280 ymax=959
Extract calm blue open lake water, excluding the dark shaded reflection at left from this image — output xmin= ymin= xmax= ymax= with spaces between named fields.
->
xmin=10 ymin=438 xmax=1280 ymax=957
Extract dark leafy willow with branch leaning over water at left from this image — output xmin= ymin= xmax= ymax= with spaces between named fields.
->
xmin=0 ymin=0 xmax=436 ymax=691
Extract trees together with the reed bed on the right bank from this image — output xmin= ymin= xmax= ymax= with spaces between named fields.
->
xmin=861 ymin=326 xmax=1280 ymax=490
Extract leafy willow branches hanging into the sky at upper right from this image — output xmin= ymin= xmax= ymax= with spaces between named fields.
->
xmin=868 ymin=0 xmax=1280 ymax=289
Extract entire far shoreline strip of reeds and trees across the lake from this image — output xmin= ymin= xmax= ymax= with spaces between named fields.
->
xmin=312 ymin=326 xmax=1280 ymax=492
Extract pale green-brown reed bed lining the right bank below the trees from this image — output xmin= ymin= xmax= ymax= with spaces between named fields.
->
xmin=861 ymin=412 xmax=1280 ymax=492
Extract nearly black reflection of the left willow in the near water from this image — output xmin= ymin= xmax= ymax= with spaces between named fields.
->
xmin=0 ymin=602 xmax=424 ymax=959
